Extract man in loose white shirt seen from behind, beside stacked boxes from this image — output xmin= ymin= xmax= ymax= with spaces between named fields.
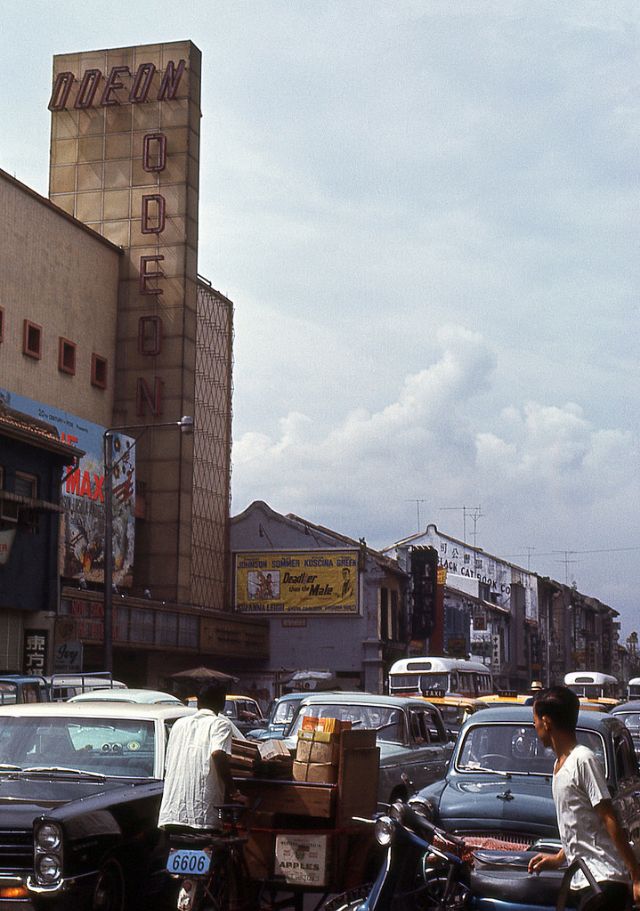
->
xmin=158 ymin=683 xmax=244 ymax=830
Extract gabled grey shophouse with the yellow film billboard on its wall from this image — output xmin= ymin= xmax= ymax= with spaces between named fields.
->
xmin=231 ymin=501 xmax=410 ymax=694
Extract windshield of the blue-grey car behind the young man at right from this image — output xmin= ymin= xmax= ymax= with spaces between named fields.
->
xmin=456 ymin=723 xmax=606 ymax=775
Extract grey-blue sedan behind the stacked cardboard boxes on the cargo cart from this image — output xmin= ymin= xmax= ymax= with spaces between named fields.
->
xmin=287 ymin=692 xmax=453 ymax=803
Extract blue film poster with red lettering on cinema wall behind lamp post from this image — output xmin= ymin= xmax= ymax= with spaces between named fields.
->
xmin=0 ymin=389 xmax=135 ymax=587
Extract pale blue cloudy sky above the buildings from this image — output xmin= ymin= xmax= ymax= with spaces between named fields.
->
xmin=5 ymin=0 xmax=640 ymax=635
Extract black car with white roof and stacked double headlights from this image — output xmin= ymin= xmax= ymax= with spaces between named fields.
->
xmin=0 ymin=702 xmax=192 ymax=911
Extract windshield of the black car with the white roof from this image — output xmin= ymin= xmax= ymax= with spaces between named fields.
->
xmin=0 ymin=715 xmax=155 ymax=778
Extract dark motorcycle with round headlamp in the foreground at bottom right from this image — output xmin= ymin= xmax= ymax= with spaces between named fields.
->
xmin=322 ymin=801 xmax=603 ymax=911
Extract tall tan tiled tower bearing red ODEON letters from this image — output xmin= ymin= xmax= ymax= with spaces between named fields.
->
xmin=49 ymin=41 xmax=201 ymax=594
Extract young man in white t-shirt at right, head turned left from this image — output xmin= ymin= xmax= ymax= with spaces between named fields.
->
xmin=529 ymin=686 xmax=640 ymax=911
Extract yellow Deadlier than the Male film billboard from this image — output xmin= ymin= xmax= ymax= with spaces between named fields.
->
xmin=236 ymin=550 xmax=358 ymax=614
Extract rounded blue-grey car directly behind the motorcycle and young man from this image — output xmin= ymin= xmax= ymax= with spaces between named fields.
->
xmin=410 ymin=706 xmax=640 ymax=850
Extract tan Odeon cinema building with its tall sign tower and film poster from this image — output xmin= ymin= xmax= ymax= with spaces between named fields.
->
xmin=0 ymin=42 xmax=268 ymax=684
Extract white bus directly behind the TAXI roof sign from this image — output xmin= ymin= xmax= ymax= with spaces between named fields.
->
xmin=389 ymin=657 xmax=493 ymax=699
